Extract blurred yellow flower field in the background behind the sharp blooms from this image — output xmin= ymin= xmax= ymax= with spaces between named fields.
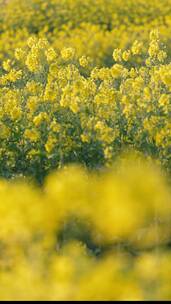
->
xmin=0 ymin=0 xmax=171 ymax=66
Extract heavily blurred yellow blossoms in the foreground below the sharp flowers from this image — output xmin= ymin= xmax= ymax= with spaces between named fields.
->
xmin=0 ymin=155 xmax=171 ymax=300
